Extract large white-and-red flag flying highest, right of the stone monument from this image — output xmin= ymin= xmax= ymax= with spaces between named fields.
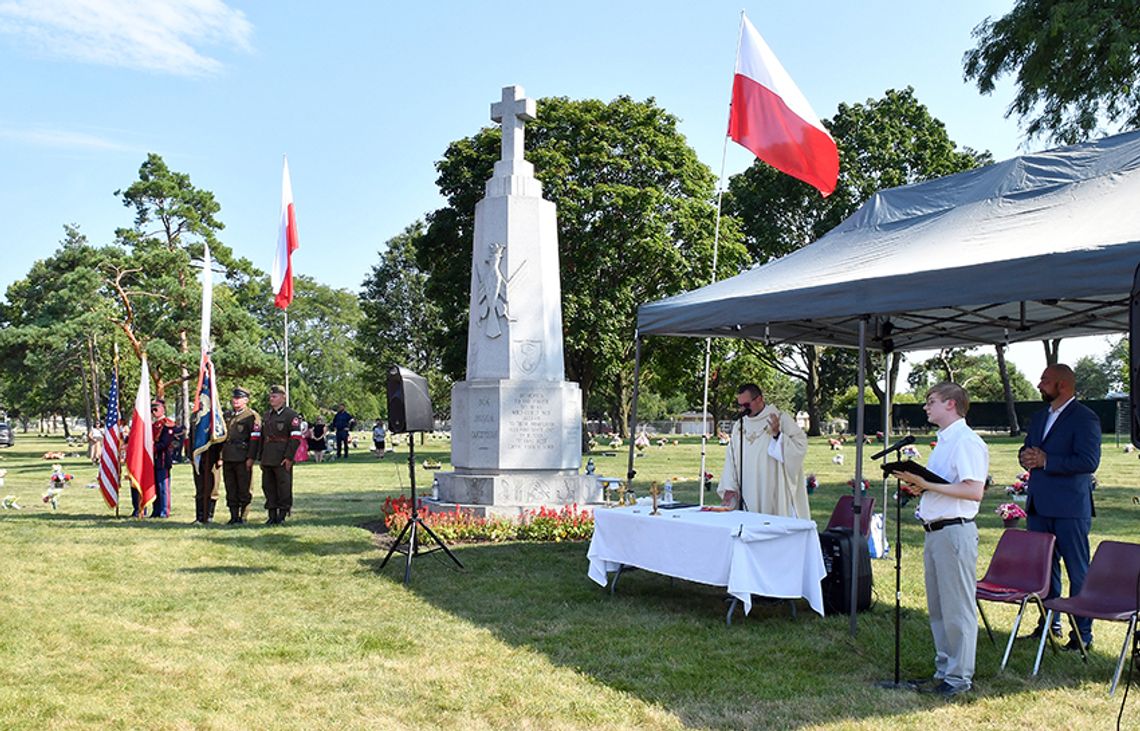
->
xmin=728 ymin=17 xmax=839 ymax=197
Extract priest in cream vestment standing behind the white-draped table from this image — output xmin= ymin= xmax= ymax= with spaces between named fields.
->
xmin=717 ymin=383 xmax=812 ymax=520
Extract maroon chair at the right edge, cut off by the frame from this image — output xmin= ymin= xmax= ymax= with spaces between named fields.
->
xmin=1033 ymin=541 xmax=1140 ymax=696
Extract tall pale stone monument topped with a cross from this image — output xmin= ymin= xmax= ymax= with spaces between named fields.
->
xmin=439 ymin=87 xmax=596 ymax=514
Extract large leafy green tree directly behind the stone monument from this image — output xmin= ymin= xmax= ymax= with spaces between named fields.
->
xmin=416 ymin=97 xmax=743 ymax=429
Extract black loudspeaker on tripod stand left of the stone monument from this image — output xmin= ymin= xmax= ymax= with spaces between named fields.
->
xmin=380 ymin=366 xmax=463 ymax=584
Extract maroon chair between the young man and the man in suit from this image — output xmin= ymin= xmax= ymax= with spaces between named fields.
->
xmin=975 ymin=528 xmax=1057 ymax=669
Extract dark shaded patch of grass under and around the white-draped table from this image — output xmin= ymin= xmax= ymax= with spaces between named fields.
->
xmin=361 ymin=526 xmax=1130 ymax=729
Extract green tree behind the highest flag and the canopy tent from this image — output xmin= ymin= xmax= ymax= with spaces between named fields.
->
xmin=725 ymin=87 xmax=991 ymax=434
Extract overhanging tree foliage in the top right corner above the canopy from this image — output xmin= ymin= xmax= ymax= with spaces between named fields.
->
xmin=963 ymin=0 xmax=1140 ymax=144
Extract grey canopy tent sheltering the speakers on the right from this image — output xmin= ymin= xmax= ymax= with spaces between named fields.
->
xmin=630 ymin=131 xmax=1140 ymax=633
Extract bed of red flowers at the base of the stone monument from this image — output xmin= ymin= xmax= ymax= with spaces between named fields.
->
xmin=383 ymin=495 xmax=594 ymax=543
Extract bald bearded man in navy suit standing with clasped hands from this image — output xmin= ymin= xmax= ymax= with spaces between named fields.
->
xmin=1018 ymin=364 xmax=1100 ymax=650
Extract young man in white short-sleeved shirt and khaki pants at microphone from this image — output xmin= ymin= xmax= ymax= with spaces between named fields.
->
xmin=898 ymin=383 xmax=990 ymax=698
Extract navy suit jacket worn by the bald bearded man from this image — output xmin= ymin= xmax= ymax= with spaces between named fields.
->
xmin=1021 ymin=401 xmax=1100 ymax=518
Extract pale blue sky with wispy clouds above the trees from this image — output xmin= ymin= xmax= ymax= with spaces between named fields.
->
xmin=0 ymin=0 xmax=1121 ymax=379
